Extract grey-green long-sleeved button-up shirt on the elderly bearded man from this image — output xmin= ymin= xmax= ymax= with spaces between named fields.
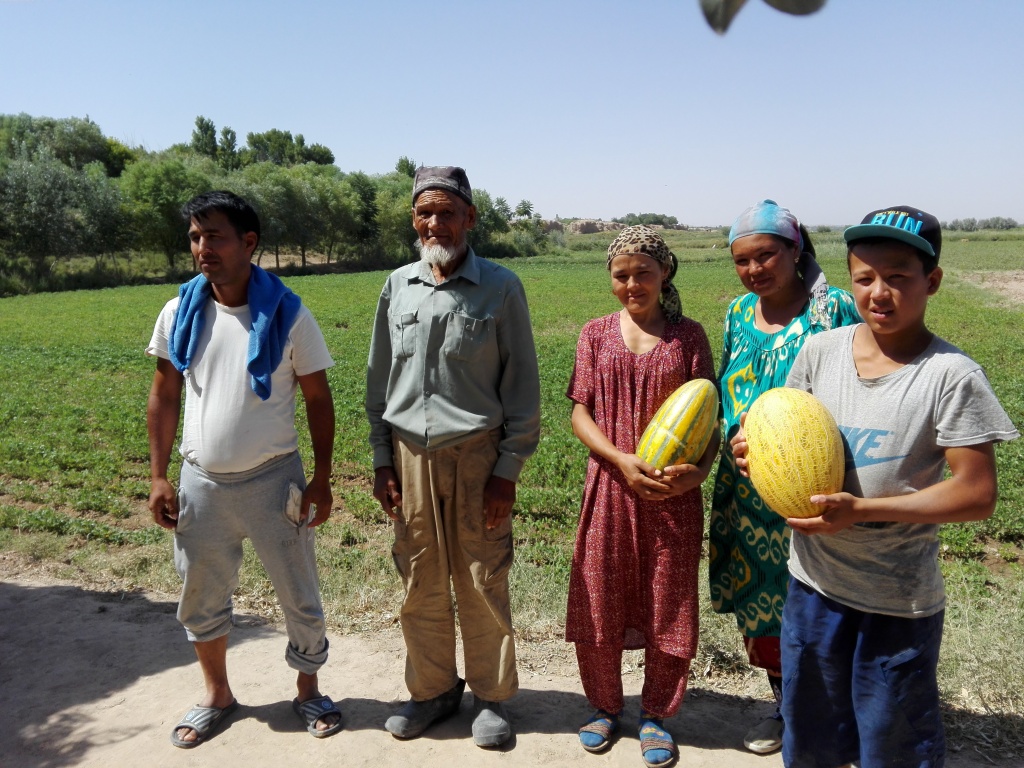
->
xmin=367 ymin=249 xmax=541 ymax=481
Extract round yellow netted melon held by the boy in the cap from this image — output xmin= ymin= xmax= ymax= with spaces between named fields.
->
xmin=743 ymin=387 xmax=845 ymax=517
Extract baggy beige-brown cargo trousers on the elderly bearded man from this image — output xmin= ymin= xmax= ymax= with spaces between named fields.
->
xmin=391 ymin=429 xmax=519 ymax=701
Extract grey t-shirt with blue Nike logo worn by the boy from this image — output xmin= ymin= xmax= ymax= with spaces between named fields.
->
xmin=786 ymin=326 xmax=1020 ymax=617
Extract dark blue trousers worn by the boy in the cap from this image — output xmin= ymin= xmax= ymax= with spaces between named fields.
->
xmin=781 ymin=579 xmax=946 ymax=768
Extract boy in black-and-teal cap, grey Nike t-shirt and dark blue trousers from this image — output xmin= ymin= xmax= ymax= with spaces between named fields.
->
xmin=734 ymin=206 xmax=1020 ymax=768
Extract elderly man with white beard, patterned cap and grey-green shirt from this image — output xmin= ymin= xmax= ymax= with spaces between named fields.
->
xmin=367 ymin=167 xmax=540 ymax=746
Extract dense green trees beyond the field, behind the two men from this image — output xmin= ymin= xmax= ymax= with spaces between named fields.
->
xmin=0 ymin=114 xmax=546 ymax=294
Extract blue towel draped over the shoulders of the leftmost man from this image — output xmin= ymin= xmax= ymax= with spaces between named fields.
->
xmin=168 ymin=264 xmax=302 ymax=400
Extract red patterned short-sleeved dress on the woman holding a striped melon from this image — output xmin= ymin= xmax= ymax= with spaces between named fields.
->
xmin=565 ymin=312 xmax=715 ymax=659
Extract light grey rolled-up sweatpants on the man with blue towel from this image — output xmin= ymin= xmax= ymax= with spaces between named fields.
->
xmin=174 ymin=453 xmax=328 ymax=675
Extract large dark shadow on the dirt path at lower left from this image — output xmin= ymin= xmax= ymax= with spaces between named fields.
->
xmin=0 ymin=582 xmax=276 ymax=768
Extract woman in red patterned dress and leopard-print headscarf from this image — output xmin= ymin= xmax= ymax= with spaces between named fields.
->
xmin=565 ymin=226 xmax=720 ymax=766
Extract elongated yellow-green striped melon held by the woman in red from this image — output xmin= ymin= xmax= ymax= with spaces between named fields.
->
xmin=637 ymin=379 xmax=718 ymax=469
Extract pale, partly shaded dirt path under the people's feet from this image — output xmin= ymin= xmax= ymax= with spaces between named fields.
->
xmin=0 ymin=575 xmax=1003 ymax=768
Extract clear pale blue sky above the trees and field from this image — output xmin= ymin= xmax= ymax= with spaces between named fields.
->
xmin=0 ymin=0 xmax=1024 ymax=225
